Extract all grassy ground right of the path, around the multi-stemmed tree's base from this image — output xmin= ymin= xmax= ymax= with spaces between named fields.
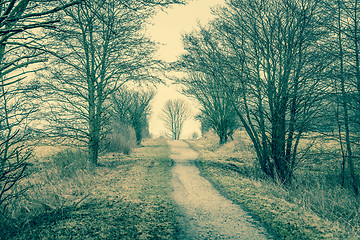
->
xmin=189 ymin=132 xmax=360 ymax=239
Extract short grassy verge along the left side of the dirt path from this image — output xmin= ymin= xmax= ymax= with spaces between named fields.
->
xmin=3 ymin=140 xmax=176 ymax=239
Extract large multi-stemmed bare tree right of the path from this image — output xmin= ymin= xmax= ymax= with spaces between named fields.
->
xmin=178 ymin=0 xmax=332 ymax=185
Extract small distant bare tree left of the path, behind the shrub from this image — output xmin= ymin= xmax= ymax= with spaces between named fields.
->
xmin=112 ymin=89 xmax=155 ymax=145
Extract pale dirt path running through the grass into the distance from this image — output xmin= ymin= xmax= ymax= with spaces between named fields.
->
xmin=169 ymin=141 xmax=272 ymax=240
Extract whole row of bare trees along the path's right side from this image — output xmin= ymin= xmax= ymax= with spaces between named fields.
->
xmin=174 ymin=0 xmax=360 ymax=191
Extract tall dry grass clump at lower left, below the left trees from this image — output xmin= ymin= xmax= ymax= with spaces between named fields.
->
xmin=0 ymin=150 xmax=95 ymax=239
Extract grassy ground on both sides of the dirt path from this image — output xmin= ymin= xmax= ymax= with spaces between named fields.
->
xmin=0 ymin=132 xmax=360 ymax=239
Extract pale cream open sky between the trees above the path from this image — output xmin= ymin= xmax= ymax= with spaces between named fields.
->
xmin=148 ymin=0 xmax=224 ymax=138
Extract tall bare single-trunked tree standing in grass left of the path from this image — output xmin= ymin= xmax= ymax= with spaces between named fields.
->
xmin=40 ymin=0 xmax=180 ymax=165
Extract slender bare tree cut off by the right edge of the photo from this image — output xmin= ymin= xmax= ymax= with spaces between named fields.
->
xmin=326 ymin=0 xmax=360 ymax=195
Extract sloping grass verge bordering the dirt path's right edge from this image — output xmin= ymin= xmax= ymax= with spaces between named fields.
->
xmin=189 ymin=132 xmax=359 ymax=239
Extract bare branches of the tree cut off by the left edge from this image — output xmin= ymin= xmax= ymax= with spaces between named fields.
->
xmin=0 ymin=0 xmax=80 ymax=214
